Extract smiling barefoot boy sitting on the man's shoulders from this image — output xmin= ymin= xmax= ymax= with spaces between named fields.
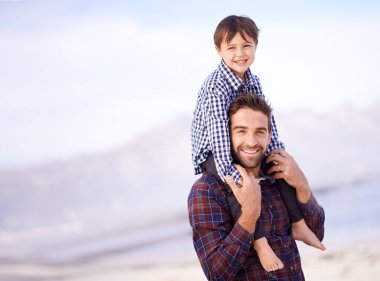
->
xmin=191 ymin=16 xmax=325 ymax=271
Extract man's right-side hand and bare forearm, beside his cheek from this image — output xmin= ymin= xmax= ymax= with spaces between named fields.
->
xmin=266 ymin=149 xmax=311 ymax=203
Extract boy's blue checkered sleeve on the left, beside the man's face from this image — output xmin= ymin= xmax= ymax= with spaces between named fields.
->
xmin=204 ymin=90 xmax=241 ymax=183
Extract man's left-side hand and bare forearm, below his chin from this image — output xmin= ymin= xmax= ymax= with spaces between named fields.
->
xmin=225 ymin=165 xmax=261 ymax=233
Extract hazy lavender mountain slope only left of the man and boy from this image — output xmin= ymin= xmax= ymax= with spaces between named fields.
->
xmin=0 ymin=117 xmax=195 ymax=231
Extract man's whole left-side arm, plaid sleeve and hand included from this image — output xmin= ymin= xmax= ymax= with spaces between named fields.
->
xmin=188 ymin=167 xmax=261 ymax=280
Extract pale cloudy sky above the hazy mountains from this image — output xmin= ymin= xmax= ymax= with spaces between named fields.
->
xmin=0 ymin=0 xmax=380 ymax=168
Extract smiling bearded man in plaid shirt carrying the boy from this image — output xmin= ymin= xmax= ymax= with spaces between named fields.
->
xmin=188 ymin=94 xmax=324 ymax=281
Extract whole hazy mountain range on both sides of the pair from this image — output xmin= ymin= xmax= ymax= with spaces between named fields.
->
xmin=0 ymin=103 xmax=380 ymax=229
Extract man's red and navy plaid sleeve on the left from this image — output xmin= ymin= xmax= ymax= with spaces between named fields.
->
xmin=189 ymin=182 xmax=253 ymax=281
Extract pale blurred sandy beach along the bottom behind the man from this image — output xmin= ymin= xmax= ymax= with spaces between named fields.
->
xmin=0 ymin=243 xmax=380 ymax=281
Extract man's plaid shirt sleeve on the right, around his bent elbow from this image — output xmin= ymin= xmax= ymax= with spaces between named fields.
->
xmin=298 ymin=194 xmax=325 ymax=241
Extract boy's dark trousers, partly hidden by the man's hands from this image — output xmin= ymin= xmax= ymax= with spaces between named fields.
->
xmin=202 ymin=154 xmax=303 ymax=240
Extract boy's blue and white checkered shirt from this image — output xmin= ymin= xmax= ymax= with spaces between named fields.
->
xmin=191 ymin=60 xmax=285 ymax=182
